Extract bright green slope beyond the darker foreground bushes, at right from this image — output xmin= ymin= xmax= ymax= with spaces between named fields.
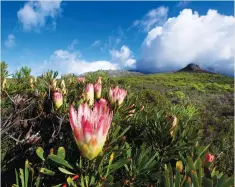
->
xmin=112 ymin=72 xmax=234 ymax=172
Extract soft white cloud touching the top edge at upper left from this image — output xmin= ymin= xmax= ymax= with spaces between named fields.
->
xmin=17 ymin=0 xmax=61 ymax=31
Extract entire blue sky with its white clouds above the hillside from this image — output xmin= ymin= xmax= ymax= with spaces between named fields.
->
xmin=1 ymin=1 xmax=234 ymax=74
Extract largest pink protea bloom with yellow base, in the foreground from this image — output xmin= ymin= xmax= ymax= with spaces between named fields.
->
xmin=70 ymin=99 xmax=113 ymax=160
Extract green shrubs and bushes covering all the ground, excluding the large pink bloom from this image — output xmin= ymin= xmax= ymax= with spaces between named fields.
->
xmin=1 ymin=62 xmax=234 ymax=187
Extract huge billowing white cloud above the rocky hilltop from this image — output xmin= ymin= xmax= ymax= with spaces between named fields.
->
xmin=137 ymin=9 xmax=235 ymax=75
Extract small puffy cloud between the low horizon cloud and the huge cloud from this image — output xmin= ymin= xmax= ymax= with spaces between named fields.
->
xmin=110 ymin=45 xmax=136 ymax=69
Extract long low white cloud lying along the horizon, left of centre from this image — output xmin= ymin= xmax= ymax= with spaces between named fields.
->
xmin=35 ymin=49 xmax=118 ymax=75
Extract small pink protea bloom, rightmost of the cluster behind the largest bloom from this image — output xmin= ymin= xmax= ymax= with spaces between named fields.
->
xmin=109 ymin=86 xmax=127 ymax=106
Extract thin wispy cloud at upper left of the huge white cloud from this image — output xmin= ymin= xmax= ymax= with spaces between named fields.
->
xmin=133 ymin=6 xmax=168 ymax=32
